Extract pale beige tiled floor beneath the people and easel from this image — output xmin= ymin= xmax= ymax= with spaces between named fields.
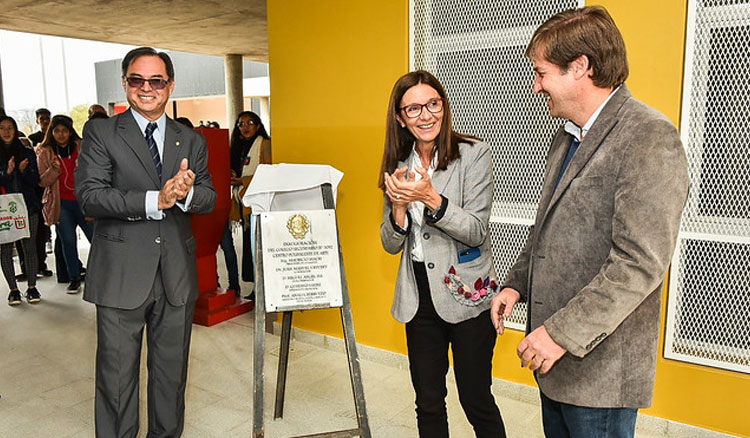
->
xmin=0 ymin=238 xmax=740 ymax=438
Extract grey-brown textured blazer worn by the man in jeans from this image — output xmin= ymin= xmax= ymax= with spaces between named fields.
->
xmin=504 ymin=85 xmax=689 ymax=408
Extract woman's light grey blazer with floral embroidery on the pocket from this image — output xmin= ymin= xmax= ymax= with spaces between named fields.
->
xmin=380 ymin=142 xmax=498 ymax=323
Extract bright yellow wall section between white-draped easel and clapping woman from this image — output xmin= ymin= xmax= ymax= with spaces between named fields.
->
xmin=268 ymin=0 xmax=409 ymax=353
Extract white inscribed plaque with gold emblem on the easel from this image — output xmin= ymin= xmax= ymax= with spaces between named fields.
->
xmin=260 ymin=210 xmax=342 ymax=312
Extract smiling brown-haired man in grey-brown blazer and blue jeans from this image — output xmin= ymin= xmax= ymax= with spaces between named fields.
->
xmin=491 ymin=7 xmax=688 ymax=437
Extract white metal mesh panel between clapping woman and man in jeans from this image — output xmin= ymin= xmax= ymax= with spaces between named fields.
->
xmin=410 ymin=0 xmax=583 ymax=329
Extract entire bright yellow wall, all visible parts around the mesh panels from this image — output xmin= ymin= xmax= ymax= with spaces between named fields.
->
xmin=268 ymin=0 xmax=750 ymax=436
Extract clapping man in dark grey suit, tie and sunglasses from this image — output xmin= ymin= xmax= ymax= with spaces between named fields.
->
xmin=75 ymin=47 xmax=216 ymax=438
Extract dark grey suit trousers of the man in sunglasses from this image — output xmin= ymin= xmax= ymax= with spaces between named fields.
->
xmin=95 ymin=273 xmax=195 ymax=438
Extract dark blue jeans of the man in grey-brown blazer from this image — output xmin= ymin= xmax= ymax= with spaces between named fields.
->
xmin=539 ymin=391 xmax=638 ymax=438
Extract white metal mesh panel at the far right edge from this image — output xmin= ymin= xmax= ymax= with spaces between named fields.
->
xmin=665 ymin=0 xmax=750 ymax=372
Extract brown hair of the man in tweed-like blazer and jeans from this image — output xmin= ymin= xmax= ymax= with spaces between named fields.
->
xmin=526 ymin=6 xmax=628 ymax=88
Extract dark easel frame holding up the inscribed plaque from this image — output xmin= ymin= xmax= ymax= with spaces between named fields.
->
xmin=253 ymin=183 xmax=371 ymax=438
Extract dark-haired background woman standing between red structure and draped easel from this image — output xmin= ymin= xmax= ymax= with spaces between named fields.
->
xmin=232 ymin=111 xmax=271 ymax=299
